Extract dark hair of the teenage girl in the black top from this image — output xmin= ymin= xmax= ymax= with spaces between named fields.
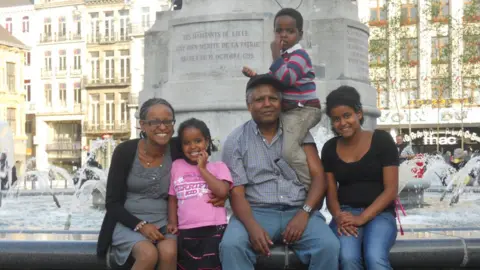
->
xmin=326 ymin=85 xmax=365 ymax=125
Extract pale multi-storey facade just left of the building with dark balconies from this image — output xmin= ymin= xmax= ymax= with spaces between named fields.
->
xmin=29 ymin=0 xmax=87 ymax=171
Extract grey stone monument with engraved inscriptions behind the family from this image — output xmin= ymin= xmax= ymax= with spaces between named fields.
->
xmin=139 ymin=0 xmax=380 ymax=146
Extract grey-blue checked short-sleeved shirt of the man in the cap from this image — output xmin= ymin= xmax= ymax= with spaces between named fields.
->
xmin=222 ymin=120 xmax=315 ymax=206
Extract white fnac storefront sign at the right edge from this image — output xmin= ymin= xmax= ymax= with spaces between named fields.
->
xmin=403 ymin=129 xmax=480 ymax=145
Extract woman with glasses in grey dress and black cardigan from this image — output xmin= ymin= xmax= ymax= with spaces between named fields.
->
xmin=97 ymin=98 xmax=224 ymax=270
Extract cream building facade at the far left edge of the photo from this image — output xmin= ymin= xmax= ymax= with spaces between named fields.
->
xmin=0 ymin=26 xmax=29 ymax=172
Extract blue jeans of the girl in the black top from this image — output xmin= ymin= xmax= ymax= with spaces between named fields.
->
xmin=330 ymin=207 xmax=397 ymax=270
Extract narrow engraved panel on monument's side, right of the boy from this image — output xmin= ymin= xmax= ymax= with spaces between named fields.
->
xmin=347 ymin=27 xmax=369 ymax=81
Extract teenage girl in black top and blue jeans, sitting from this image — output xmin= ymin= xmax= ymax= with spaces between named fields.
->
xmin=322 ymin=86 xmax=399 ymax=270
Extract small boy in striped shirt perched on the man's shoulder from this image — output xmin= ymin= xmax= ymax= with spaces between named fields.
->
xmin=243 ymin=8 xmax=322 ymax=190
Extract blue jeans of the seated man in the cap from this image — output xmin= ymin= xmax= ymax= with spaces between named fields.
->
xmin=220 ymin=207 xmax=340 ymax=270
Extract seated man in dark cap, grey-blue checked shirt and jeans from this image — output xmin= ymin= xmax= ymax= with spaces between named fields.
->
xmin=220 ymin=75 xmax=340 ymax=270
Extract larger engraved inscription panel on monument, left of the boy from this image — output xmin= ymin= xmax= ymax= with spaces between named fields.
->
xmin=172 ymin=20 xmax=263 ymax=80
